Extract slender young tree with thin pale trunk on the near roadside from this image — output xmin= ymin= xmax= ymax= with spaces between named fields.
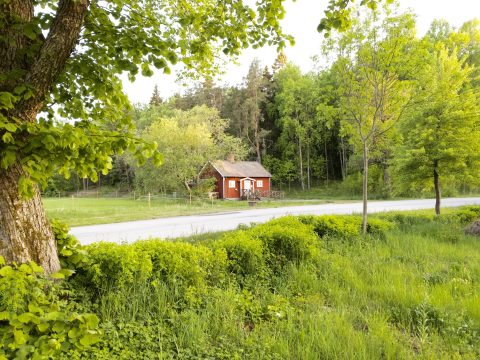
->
xmin=330 ymin=8 xmax=416 ymax=233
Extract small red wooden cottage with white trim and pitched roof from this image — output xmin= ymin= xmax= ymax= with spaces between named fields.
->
xmin=199 ymin=159 xmax=272 ymax=199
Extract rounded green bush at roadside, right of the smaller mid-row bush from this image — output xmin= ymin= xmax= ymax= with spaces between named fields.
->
xmin=247 ymin=216 xmax=320 ymax=270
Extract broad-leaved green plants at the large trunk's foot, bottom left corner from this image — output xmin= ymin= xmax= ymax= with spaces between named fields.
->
xmin=0 ymin=257 xmax=101 ymax=359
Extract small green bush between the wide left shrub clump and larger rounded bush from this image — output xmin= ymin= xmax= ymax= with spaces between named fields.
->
xmin=211 ymin=231 xmax=265 ymax=283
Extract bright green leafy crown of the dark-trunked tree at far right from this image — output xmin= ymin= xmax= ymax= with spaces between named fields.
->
xmin=394 ymin=43 xmax=480 ymax=205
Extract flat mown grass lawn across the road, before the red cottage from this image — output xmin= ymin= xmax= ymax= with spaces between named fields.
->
xmin=43 ymin=198 xmax=346 ymax=226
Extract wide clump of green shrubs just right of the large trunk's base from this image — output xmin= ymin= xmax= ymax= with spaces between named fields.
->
xmin=83 ymin=240 xmax=227 ymax=307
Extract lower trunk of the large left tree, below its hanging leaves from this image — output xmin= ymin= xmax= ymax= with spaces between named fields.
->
xmin=0 ymin=164 xmax=60 ymax=274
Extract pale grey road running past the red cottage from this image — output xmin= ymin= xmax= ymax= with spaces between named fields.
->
xmin=70 ymin=198 xmax=480 ymax=245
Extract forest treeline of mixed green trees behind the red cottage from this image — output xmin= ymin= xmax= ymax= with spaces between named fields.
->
xmin=46 ymin=8 xmax=480 ymax=202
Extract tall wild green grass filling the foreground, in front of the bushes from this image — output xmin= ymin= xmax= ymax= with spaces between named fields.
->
xmin=62 ymin=210 xmax=480 ymax=359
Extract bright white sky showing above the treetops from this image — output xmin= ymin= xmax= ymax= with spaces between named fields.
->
xmin=123 ymin=0 xmax=480 ymax=103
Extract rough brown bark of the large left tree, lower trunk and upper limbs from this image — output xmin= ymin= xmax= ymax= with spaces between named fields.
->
xmin=0 ymin=0 xmax=89 ymax=274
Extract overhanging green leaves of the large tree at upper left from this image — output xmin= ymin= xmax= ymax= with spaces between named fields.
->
xmin=0 ymin=0 xmax=292 ymax=196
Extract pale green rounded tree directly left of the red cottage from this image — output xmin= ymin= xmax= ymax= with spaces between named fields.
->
xmin=135 ymin=106 xmax=245 ymax=193
